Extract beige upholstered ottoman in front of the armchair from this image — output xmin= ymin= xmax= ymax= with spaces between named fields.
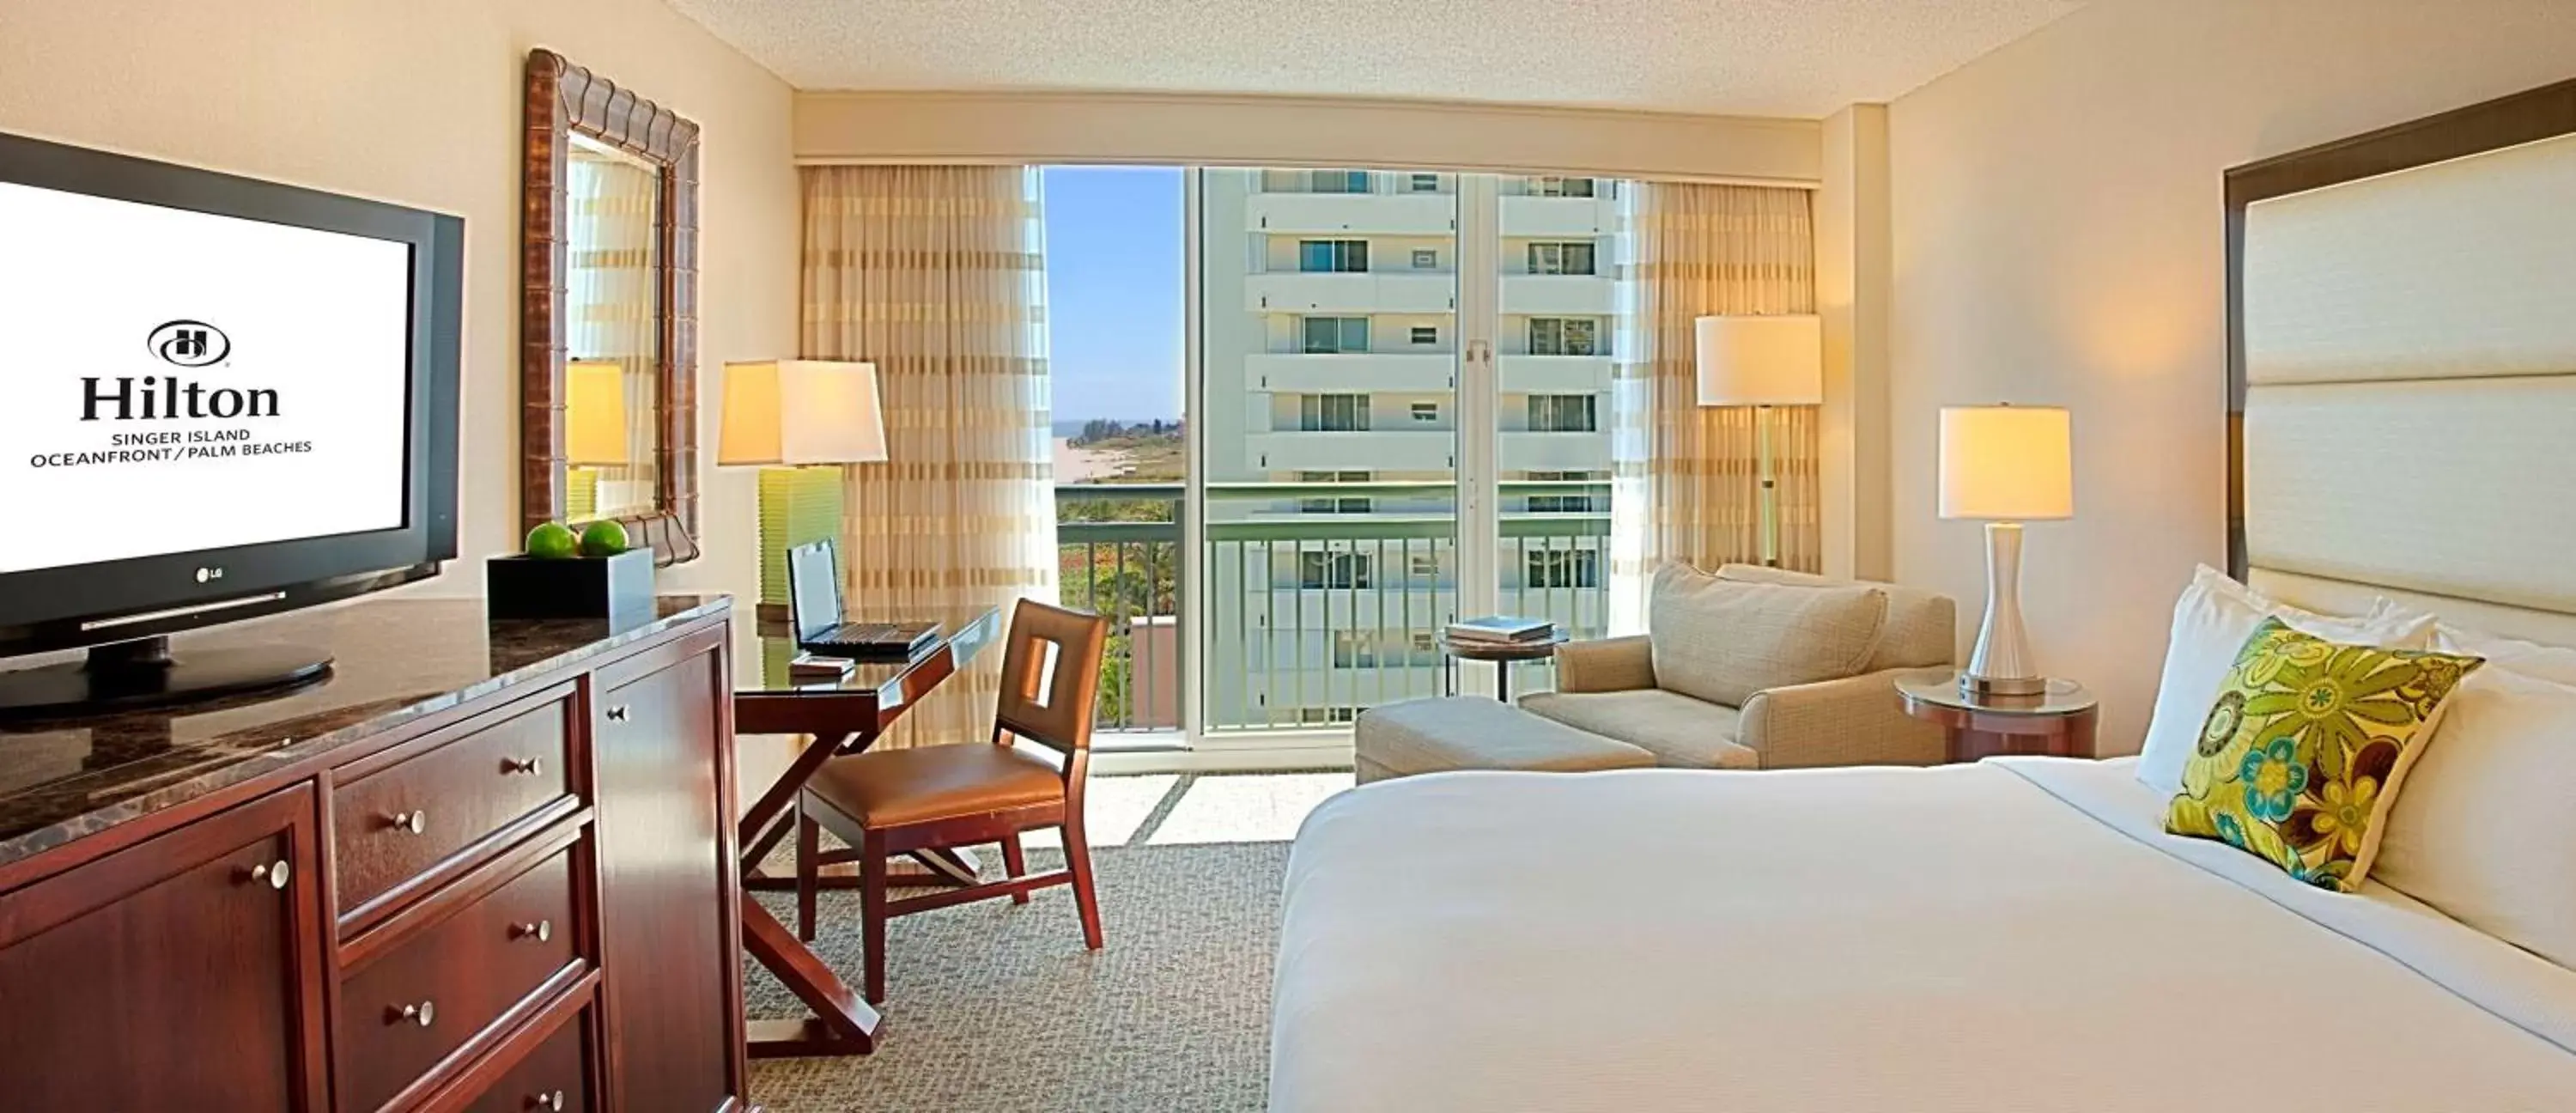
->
xmin=1352 ymin=696 xmax=1654 ymax=783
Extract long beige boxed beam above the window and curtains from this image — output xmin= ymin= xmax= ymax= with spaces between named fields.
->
xmin=796 ymin=93 xmax=1821 ymax=183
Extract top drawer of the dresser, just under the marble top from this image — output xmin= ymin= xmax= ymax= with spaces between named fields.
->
xmin=332 ymin=690 xmax=572 ymax=920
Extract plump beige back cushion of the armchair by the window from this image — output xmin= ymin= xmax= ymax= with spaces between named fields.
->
xmin=1646 ymin=564 xmax=1888 ymax=709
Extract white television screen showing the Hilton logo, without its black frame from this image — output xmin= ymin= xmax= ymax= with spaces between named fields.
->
xmin=0 ymin=183 xmax=412 ymax=575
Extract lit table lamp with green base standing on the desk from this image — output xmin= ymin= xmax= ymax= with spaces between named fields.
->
xmin=716 ymin=361 xmax=886 ymax=605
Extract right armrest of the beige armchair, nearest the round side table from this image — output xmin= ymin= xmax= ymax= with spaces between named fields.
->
xmin=1736 ymin=670 xmax=1950 ymax=768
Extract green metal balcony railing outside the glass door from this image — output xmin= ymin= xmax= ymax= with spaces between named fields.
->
xmin=1056 ymin=482 xmax=1610 ymax=732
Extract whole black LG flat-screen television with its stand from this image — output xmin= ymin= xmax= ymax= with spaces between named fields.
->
xmin=0 ymin=134 xmax=464 ymax=716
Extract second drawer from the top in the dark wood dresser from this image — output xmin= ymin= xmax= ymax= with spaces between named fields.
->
xmin=335 ymin=848 xmax=582 ymax=1113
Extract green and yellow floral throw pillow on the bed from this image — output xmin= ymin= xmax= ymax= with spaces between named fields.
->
xmin=2164 ymin=618 xmax=2486 ymax=891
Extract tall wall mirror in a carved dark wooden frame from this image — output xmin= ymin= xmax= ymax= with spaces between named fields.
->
xmin=518 ymin=49 xmax=698 ymax=564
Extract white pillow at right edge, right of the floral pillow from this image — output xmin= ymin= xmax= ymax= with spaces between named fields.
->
xmin=2370 ymin=665 xmax=2576 ymax=969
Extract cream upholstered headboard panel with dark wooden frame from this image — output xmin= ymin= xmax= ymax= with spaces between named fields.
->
xmin=2228 ymin=82 xmax=2576 ymax=644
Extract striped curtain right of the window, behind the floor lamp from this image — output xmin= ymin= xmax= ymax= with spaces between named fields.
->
xmin=1610 ymin=183 xmax=1824 ymax=634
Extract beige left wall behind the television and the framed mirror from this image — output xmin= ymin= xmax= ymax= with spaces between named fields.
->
xmin=0 ymin=0 xmax=799 ymax=605
